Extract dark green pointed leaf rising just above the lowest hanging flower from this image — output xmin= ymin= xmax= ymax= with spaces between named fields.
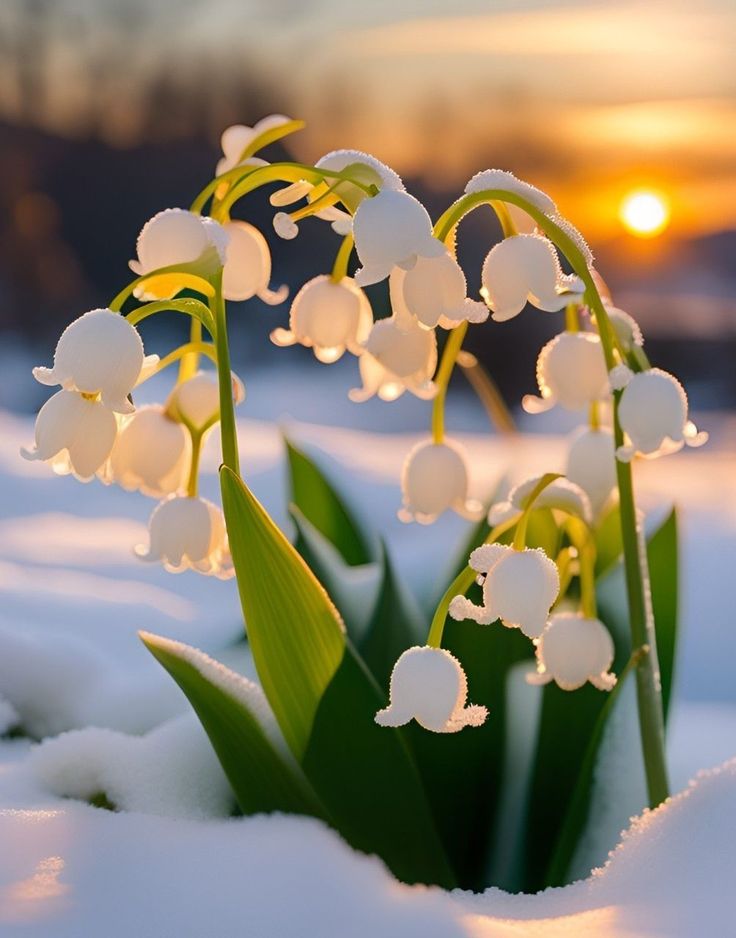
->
xmin=358 ymin=541 xmax=429 ymax=687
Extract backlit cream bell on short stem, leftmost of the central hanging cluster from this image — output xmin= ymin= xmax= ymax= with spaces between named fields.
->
xmin=271 ymin=274 xmax=373 ymax=364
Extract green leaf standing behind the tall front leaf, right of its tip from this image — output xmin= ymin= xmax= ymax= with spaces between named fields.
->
xmin=286 ymin=439 xmax=376 ymax=566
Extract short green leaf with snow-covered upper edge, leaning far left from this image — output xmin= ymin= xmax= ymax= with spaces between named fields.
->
xmin=140 ymin=632 xmax=324 ymax=817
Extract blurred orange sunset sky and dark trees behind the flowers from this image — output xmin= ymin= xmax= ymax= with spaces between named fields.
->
xmin=0 ymin=0 xmax=736 ymax=435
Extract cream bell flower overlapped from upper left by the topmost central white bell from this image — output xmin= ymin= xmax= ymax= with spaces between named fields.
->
xmin=389 ymin=251 xmax=488 ymax=329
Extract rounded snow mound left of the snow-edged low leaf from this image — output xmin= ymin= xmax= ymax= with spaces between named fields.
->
xmin=29 ymin=714 xmax=234 ymax=818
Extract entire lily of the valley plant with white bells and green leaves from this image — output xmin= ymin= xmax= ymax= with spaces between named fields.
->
xmin=24 ymin=116 xmax=703 ymax=888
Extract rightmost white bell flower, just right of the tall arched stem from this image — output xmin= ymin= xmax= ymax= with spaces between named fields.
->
xmin=612 ymin=366 xmax=708 ymax=462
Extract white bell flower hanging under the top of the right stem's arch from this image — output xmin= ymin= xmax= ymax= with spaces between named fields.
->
xmin=480 ymin=234 xmax=584 ymax=322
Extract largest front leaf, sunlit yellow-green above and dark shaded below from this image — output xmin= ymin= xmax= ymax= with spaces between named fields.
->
xmin=220 ymin=468 xmax=454 ymax=886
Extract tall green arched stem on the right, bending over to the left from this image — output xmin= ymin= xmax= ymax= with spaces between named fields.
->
xmin=437 ymin=189 xmax=669 ymax=807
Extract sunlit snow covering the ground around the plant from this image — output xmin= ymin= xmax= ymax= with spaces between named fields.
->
xmin=0 ymin=405 xmax=736 ymax=938
